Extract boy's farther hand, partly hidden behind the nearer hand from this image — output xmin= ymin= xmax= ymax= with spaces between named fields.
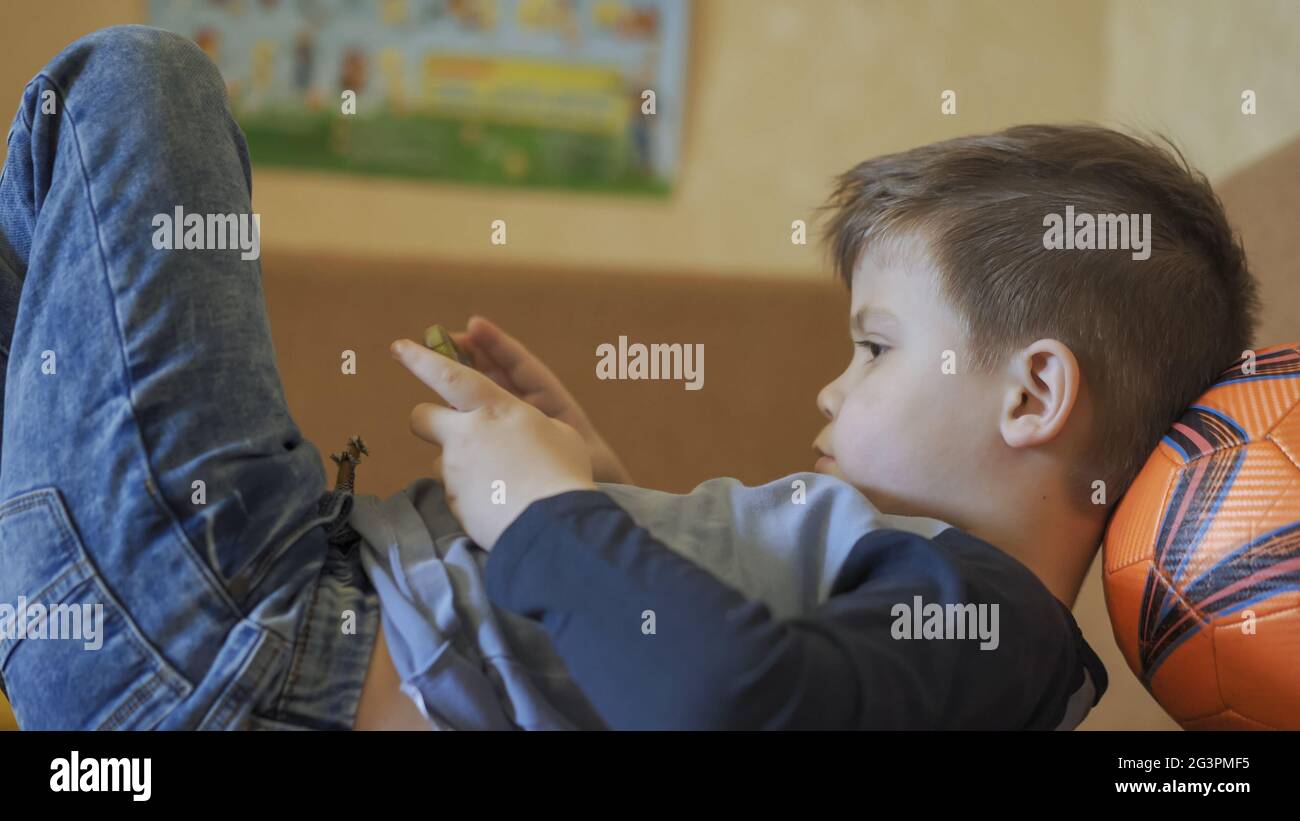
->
xmin=451 ymin=316 xmax=632 ymax=485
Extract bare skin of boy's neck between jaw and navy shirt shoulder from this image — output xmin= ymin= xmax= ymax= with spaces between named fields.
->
xmin=963 ymin=496 xmax=1108 ymax=609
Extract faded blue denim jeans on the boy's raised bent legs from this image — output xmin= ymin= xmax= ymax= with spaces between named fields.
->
xmin=0 ymin=26 xmax=378 ymax=729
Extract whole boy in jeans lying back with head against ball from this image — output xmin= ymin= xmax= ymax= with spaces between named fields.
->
xmin=0 ymin=27 xmax=1253 ymax=727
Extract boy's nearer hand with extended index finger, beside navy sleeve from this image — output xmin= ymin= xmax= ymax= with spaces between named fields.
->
xmin=389 ymin=339 xmax=595 ymax=549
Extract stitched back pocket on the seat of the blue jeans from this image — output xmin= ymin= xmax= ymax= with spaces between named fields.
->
xmin=0 ymin=487 xmax=192 ymax=730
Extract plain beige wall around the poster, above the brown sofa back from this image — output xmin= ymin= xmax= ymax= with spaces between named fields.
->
xmin=0 ymin=0 xmax=1300 ymax=277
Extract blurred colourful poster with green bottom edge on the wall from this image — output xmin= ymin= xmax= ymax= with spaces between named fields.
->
xmin=150 ymin=0 xmax=689 ymax=195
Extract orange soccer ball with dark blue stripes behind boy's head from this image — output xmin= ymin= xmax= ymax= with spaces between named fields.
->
xmin=1102 ymin=343 xmax=1300 ymax=730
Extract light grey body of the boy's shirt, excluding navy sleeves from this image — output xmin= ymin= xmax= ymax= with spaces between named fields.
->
xmin=350 ymin=473 xmax=949 ymax=730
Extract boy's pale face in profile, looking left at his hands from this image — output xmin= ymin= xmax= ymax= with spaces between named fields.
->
xmin=813 ymin=239 xmax=1005 ymax=524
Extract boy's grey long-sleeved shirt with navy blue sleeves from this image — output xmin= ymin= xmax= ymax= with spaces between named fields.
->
xmin=352 ymin=473 xmax=1106 ymax=729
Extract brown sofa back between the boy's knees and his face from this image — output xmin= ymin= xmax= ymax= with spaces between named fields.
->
xmin=263 ymin=259 xmax=852 ymax=495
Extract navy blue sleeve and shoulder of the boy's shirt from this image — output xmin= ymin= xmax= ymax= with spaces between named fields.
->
xmin=485 ymin=491 xmax=1102 ymax=729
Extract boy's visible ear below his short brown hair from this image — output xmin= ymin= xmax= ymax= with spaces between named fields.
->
xmin=1000 ymin=339 xmax=1080 ymax=448
